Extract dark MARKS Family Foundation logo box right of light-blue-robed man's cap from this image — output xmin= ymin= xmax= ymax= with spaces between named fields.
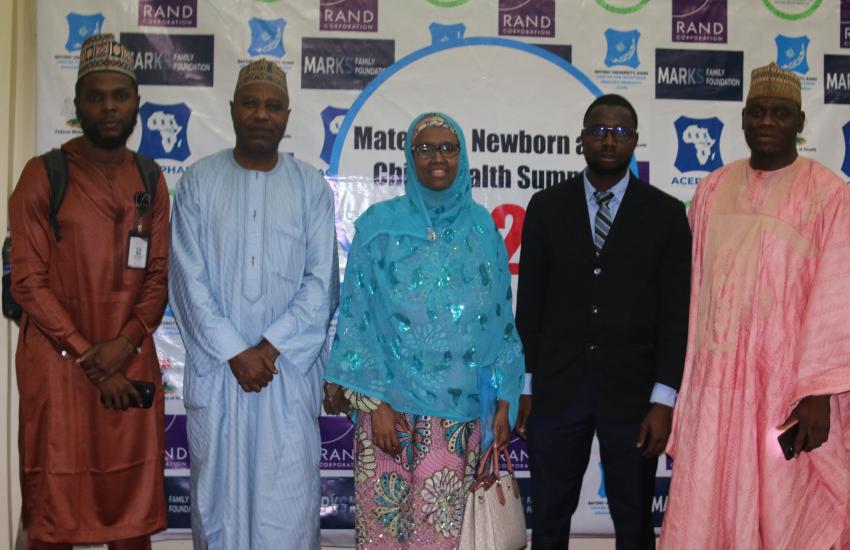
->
xmin=301 ymin=38 xmax=395 ymax=90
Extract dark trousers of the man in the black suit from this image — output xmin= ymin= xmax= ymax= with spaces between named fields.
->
xmin=528 ymin=381 xmax=658 ymax=550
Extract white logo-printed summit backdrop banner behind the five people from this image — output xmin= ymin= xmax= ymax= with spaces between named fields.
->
xmin=37 ymin=0 xmax=850 ymax=546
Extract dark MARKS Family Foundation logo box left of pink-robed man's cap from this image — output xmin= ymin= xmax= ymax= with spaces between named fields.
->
xmin=655 ymin=48 xmax=744 ymax=101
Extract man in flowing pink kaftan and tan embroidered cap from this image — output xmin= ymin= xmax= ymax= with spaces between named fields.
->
xmin=660 ymin=64 xmax=850 ymax=550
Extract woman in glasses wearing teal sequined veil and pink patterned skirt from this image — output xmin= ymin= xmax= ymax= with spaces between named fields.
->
xmin=326 ymin=113 xmax=524 ymax=550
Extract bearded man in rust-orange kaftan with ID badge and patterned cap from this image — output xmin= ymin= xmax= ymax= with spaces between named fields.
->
xmin=9 ymin=35 xmax=169 ymax=550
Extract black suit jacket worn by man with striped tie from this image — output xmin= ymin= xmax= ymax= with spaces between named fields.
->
xmin=516 ymin=175 xmax=691 ymax=421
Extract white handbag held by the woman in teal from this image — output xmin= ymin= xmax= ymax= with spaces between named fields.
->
xmin=458 ymin=446 xmax=528 ymax=550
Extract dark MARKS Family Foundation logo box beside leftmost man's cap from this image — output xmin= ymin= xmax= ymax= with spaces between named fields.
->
xmin=121 ymin=32 xmax=215 ymax=86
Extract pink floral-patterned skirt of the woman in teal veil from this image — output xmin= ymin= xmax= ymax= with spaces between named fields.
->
xmin=354 ymin=413 xmax=481 ymax=550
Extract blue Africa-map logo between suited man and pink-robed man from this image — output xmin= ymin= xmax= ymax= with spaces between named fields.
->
xmin=673 ymin=116 xmax=723 ymax=185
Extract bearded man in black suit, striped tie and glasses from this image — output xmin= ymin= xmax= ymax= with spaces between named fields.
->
xmin=516 ymin=94 xmax=691 ymax=550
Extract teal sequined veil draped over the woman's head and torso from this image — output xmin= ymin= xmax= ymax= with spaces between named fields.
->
xmin=326 ymin=115 xmax=525 ymax=446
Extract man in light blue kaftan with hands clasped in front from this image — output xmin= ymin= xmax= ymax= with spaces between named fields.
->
xmin=169 ymin=60 xmax=339 ymax=550
